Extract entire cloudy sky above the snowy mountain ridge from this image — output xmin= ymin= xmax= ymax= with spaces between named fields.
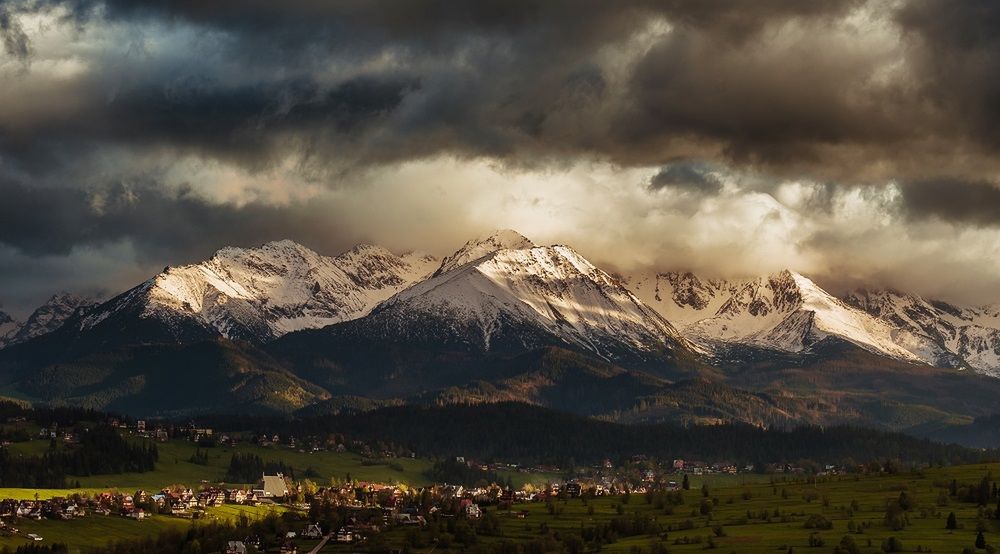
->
xmin=0 ymin=0 xmax=1000 ymax=316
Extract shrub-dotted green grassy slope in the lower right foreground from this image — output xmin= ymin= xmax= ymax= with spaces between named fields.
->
xmin=362 ymin=464 xmax=1000 ymax=554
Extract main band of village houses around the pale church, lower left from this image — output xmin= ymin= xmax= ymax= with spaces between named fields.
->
xmin=0 ymin=457 xmax=836 ymax=554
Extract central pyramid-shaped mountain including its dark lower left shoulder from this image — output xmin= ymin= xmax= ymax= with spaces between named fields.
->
xmin=273 ymin=231 xmax=690 ymax=384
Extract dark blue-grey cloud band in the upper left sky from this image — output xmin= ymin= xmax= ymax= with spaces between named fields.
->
xmin=0 ymin=75 xmax=419 ymax=172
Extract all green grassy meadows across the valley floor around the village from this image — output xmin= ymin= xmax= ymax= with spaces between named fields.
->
xmin=0 ymin=441 xmax=1000 ymax=554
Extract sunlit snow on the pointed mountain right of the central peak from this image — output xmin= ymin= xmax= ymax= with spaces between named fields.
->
xmin=632 ymin=270 xmax=943 ymax=363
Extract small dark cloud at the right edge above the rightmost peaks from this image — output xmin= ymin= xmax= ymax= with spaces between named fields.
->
xmin=901 ymin=178 xmax=1000 ymax=226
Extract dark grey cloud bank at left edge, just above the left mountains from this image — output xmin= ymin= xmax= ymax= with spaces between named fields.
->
xmin=0 ymin=182 xmax=351 ymax=262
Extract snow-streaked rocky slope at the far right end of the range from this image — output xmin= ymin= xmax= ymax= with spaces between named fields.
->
xmin=844 ymin=289 xmax=1000 ymax=377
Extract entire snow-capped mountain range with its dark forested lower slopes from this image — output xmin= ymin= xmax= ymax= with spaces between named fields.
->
xmin=0 ymin=230 xmax=1000 ymax=440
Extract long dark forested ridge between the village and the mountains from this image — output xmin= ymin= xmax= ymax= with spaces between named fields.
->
xmin=230 ymin=402 xmax=1000 ymax=465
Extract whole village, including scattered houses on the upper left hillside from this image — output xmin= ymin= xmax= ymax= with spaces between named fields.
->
xmin=0 ymin=419 xmax=843 ymax=554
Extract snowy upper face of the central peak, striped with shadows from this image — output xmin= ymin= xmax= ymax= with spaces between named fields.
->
xmin=369 ymin=231 xmax=685 ymax=359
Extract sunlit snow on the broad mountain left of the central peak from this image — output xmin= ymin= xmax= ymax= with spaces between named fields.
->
xmin=81 ymin=240 xmax=437 ymax=342
